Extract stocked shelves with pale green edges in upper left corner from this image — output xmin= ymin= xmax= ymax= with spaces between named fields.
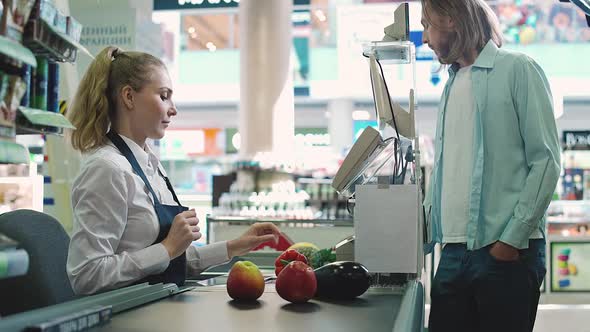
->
xmin=0 ymin=0 xmax=88 ymax=163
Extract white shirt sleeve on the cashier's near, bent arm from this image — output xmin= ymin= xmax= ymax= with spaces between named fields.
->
xmin=67 ymin=159 xmax=170 ymax=294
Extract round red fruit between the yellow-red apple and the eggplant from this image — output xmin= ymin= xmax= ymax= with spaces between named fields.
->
xmin=275 ymin=261 xmax=317 ymax=303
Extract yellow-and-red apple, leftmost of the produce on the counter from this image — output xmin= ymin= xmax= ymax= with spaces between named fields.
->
xmin=227 ymin=261 xmax=264 ymax=301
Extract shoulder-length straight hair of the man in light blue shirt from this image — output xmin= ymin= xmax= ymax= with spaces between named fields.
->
xmin=422 ymin=0 xmax=502 ymax=64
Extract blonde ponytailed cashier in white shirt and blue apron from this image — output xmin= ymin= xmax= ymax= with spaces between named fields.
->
xmin=67 ymin=47 xmax=279 ymax=294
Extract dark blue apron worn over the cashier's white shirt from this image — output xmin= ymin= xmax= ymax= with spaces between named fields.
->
xmin=107 ymin=131 xmax=188 ymax=286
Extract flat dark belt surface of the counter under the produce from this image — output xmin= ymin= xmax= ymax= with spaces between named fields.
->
xmin=97 ymin=284 xmax=412 ymax=332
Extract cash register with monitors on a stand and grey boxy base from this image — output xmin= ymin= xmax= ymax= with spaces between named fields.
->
xmin=332 ymin=3 xmax=425 ymax=280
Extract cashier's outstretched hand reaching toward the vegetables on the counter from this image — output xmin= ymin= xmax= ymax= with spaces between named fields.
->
xmin=227 ymin=222 xmax=281 ymax=259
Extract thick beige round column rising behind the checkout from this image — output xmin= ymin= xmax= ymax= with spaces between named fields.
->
xmin=239 ymin=0 xmax=294 ymax=159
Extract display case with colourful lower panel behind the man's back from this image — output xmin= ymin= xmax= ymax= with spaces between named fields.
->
xmin=546 ymin=131 xmax=590 ymax=293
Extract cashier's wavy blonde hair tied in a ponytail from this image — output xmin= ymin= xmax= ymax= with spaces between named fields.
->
xmin=67 ymin=46 xmax=165 ymax=152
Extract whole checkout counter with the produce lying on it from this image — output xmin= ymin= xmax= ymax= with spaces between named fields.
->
xmin=0 ymin=270 xmax=424 ymax=332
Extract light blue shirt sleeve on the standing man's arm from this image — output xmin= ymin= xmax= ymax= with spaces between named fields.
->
xmin=500 ymin=57 xmax=560 ymax=248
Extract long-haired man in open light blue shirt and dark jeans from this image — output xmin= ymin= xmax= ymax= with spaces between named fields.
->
xmin=422 ymin=0 xmax=560 ymax=332
